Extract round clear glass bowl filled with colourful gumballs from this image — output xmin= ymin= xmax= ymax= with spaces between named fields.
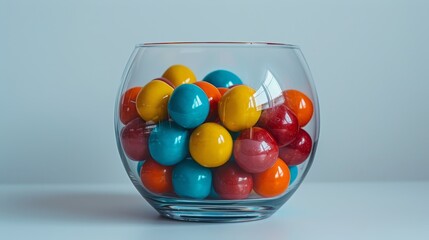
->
xmin=114 ymin=42 xmax=319 ymax=222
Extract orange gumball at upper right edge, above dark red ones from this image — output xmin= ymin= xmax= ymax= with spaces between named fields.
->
xmin=283 ymin=90 xmax=314 ymax=127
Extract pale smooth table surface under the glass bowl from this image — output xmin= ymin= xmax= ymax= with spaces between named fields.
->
xmin=0 ymin=182 xmax=429 ymax=240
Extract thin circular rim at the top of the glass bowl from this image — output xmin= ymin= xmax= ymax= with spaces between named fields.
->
xmin=136 ymin=41 xmax=299 ymax=49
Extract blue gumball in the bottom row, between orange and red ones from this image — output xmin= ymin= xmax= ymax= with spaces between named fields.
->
xmin=173 ymin=158 xmax=212 ymax=199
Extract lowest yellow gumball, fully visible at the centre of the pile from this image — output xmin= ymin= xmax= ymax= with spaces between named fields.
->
xmin=189 ymin=122 xmax=232 ymax=168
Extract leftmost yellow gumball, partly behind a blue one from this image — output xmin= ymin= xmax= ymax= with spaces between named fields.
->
xmin=136 ymin=80 xmax=174 ymax=122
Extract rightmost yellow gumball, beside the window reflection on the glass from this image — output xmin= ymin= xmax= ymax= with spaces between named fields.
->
xmin=218 ymin=85 xmax=261 ymax=132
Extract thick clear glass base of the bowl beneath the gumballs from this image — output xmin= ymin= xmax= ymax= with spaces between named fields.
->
xmin=146 ymin=197 xmax=283 ymax=223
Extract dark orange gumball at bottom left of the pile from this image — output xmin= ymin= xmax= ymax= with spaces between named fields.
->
xmin=140 ymin=159 xmax=173 ymax=194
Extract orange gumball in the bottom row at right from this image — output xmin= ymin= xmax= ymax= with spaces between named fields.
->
xmin=253 ymin=158 xmax=290 ymax=197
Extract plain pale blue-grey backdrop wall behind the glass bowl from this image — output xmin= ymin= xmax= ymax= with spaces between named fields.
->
xmin=0 ymin=0 xmax=429 ymax=183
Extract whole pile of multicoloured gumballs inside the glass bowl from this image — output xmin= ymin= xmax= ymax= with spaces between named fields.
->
xmin=118 ymin=65 xmax=314 ymax=200
